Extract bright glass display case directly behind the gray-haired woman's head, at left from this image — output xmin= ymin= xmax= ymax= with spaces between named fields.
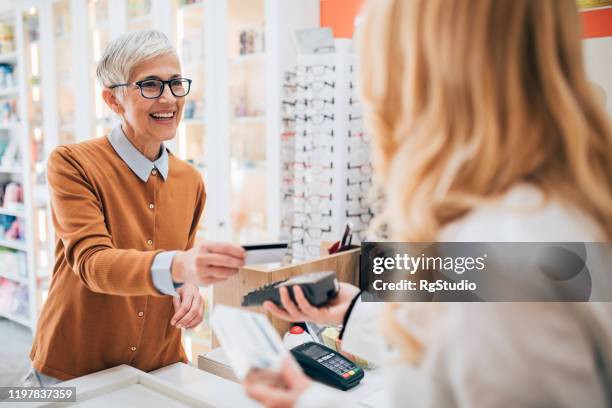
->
xmin=87 ymin=0 xmax=118 ymax=137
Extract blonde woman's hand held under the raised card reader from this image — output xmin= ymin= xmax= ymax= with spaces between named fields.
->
xmin=263 ymin=282 xmax=359 ymax=325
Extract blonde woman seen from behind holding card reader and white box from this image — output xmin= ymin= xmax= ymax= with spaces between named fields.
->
xmin=246 ymin=0 xmax=612 ymax=407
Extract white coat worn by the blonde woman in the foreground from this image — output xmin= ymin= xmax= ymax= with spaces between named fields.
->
xmin=296 ymin=185 xmax=612 ymax=408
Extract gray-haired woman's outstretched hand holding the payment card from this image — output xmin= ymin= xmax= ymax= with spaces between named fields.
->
xmin=171 ymin=241 xmax=246 ymax=286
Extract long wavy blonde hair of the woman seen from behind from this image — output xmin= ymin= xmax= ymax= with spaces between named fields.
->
xmin=358 ymin=0 xmax=612 ymax=362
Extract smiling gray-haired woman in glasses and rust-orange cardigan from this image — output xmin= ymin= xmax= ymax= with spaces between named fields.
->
xmin=26 ymin=31 xmax=244 ymax=386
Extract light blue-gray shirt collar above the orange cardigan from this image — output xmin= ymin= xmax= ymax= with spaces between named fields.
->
xmin=108 ymin=125 xmax=168 ymax=183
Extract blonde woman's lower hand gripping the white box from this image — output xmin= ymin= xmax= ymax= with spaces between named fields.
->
xmin=244 ymin=357 xmax=312 ymax=408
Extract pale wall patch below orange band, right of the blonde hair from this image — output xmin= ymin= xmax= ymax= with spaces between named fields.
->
xmin=583 ymin=37 xmax=612 ymax=119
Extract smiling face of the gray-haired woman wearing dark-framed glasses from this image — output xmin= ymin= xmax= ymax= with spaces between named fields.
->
xmin=122 ymin=54 xmax=185 ymax=143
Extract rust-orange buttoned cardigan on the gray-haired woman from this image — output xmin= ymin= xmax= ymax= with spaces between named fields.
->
xmin=30 ymin=138 xmax=206 ymax=380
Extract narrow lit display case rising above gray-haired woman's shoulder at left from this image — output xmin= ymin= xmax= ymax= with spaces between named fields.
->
xmin=52 ymin=0 xmax=76 ymax=144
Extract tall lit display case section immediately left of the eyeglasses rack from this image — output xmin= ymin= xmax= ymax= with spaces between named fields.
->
xmin=226 ymin=0 xmax=269 ymax=242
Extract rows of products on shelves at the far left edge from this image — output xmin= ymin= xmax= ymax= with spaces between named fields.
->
xmin=0 ymin=9 xmax=35 ymax=327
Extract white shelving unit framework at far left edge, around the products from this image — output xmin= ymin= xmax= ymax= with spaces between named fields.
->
xmin=0 ymin=3 xmax=40 ymax=330
